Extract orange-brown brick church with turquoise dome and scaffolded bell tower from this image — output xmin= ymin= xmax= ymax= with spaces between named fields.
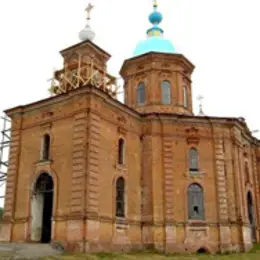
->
xmin=0 ymin=2 xmax=260 ymax=252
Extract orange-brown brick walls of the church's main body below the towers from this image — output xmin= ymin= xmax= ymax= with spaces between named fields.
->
xmin=3 ymin=88 xmax=260 ymax=251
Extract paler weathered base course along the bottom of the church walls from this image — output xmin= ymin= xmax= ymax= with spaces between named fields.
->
xmin=0 ymin=220 xmax=252 ymax=253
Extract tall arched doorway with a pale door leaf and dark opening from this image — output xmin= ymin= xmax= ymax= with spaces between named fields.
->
xmin=31 ymin=173 xmax=53 ymax=243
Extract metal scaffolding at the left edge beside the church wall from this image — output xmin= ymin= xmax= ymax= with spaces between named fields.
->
xmin=0 ymin=115 xmax=11 ymax=199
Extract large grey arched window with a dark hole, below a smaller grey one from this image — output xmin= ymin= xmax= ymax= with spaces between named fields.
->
xmin=188 ymin=183 xmax=205 ymax=220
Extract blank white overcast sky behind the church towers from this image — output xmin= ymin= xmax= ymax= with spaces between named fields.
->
xmin=0 ymin=0 xmax=260 ymax=201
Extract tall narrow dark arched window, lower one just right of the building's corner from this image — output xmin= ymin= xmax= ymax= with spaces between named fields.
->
xmin=116 ymin=177 xmax=125 ymax=218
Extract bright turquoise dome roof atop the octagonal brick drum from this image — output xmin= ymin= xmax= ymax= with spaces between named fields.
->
xmin=134 ymin=36 xmax=175 ymax=57
